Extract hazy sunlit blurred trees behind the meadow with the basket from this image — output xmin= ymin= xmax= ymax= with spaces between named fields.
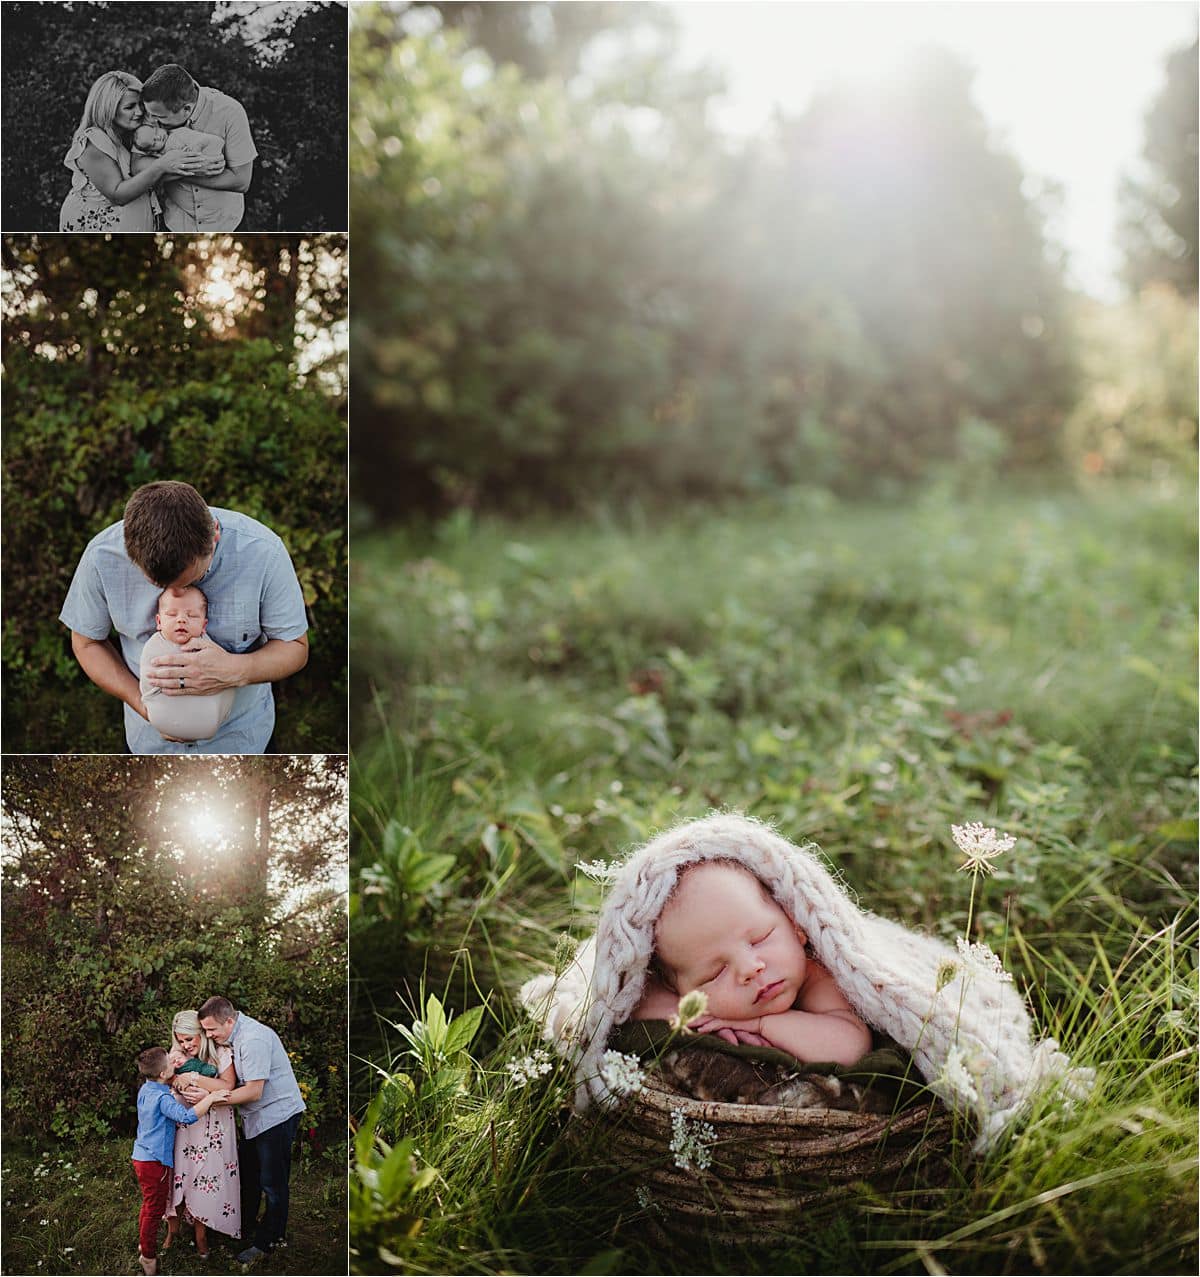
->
xmin=350 ymin=4 xmax=1196 ymax=520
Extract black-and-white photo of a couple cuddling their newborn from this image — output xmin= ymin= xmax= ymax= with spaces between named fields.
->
xmin=0 ymin=0 xmax=347 ymax=232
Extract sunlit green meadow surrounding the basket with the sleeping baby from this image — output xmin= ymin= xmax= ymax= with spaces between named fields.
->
xmin=350 ymin=471 xmax=1197 ymax=1273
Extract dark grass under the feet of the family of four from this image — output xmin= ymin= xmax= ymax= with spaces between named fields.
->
xmin=3 ymin=1137 xmax=346 ymax=1273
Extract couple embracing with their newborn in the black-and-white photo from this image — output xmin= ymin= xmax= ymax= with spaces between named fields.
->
xmin=59 ymin=63 xmax=258 ymax=231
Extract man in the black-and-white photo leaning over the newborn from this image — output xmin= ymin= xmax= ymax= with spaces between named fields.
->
xmin=133 ymin=63 xmax=258 ymax=231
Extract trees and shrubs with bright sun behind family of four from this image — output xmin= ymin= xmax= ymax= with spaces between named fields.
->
xmin=3 ymin=756 xmax=346 ymax=1140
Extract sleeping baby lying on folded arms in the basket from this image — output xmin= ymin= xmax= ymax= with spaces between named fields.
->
xmin=632 ymin=861 xmax=871 ymax=1064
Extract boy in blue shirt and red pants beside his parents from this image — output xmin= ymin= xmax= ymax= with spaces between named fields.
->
xmin=133 ymin=1046 xmax=229 ymax=1274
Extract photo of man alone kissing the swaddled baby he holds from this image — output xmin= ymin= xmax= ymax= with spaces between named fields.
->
xmin=3 ymin=234 xmax=347 ymax=753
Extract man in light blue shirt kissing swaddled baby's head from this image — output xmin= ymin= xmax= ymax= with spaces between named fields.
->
xmin=59 ymin=480 xmax=309 ymax=753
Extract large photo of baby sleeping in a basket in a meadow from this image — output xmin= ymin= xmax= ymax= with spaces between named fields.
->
xmin=350 ymin=4 xmax=1197 ymax=1274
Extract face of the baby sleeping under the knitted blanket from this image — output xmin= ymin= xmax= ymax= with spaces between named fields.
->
xmin=655 ymin=865 xmax=807 ymax=1020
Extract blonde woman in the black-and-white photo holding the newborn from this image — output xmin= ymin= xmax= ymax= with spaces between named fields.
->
xmin=59 ymin=72 xmax=215 ymax=231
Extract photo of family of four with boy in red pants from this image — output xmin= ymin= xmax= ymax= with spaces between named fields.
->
xmin=0 ymin=755 xmax=347 ymax=1273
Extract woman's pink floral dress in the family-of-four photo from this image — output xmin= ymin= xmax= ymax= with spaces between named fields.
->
xmin=166 ymin=1046 xmax=241 ymax=1237
